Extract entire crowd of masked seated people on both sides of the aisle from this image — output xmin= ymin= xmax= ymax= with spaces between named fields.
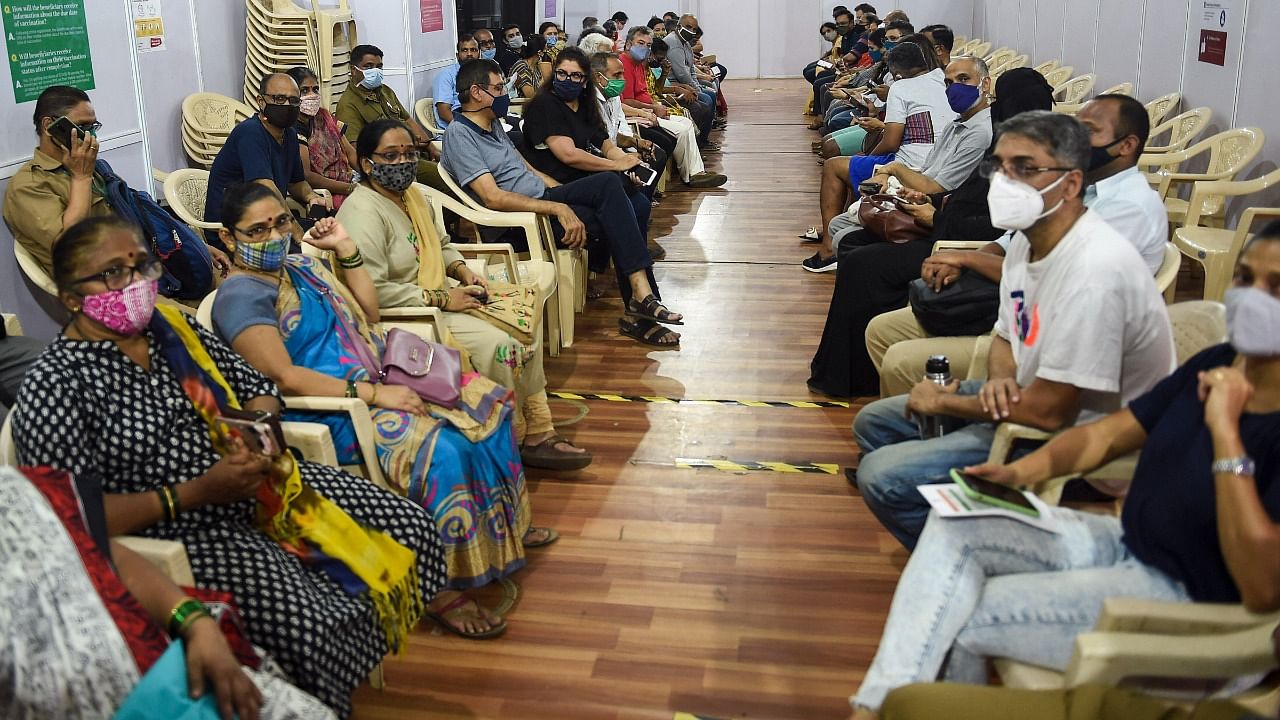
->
xmin=0 ymin=4 xmax=1280 ymax=719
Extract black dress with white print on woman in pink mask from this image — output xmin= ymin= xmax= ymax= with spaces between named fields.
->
xmin=13 ymin=319 xmax=447 ymax=716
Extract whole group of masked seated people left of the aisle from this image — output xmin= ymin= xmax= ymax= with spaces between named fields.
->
xmin=0 ymin=7 xmax=727 ymax=719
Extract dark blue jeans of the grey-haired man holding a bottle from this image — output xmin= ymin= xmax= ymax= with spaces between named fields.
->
xmin=854 ymin=380 xmax=996 ymax=550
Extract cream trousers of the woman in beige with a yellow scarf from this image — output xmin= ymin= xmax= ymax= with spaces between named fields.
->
xmin=444 ymin=313 xmax=553 ymax=441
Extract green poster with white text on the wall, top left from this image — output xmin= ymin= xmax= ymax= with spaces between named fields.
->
xmin=4 ymin=0 xmax=95 ymax=102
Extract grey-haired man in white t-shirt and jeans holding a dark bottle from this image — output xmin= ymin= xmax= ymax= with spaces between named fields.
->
xmin=854 ymin=111 xmax=1175 ymax=548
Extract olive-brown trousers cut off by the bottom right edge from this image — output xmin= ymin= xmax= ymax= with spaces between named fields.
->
xmin=879 ymin=683 xmax=1248 ymax=720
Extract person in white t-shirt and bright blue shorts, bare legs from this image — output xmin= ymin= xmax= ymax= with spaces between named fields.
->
xmin=801 ymin=42 xmax=956 ymax=273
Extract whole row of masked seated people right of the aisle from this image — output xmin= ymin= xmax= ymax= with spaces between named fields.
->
xmin=800 ymin=4 xmax=1280 ymax=719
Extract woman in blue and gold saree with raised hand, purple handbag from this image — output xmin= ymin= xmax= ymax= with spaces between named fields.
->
xmin=214 ymin=183 xmax=556 ymax=638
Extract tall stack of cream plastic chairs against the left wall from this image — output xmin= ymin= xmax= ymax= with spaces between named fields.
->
xmin=244 ymin=0 xmax=356 ymax=110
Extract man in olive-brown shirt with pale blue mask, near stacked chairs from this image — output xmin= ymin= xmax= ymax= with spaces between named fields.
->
xmin=337 ymin=45 xmax=449 ymax=192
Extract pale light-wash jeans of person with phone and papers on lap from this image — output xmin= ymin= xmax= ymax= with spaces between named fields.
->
xmin=849 ymin=507 xmax=1190 ymax=710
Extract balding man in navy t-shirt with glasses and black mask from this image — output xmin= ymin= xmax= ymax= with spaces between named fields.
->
xmin=205 ymin=73 xmax=326 ymax=250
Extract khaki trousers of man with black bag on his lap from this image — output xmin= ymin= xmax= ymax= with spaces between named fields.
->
xmin=867 ymin=307 xmax=986 ymax=397
